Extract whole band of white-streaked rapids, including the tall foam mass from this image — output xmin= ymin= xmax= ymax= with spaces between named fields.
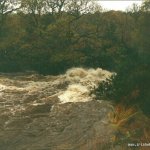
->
xmin=0 ymin=68 xmax=112 ymax=114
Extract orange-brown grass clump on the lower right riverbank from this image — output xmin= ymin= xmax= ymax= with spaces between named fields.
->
xmin=109 ymin=104 xmax=150 ymax=150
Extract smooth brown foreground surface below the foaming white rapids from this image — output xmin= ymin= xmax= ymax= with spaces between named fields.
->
xmin=0 ymin=101 xmax=114 ymax=150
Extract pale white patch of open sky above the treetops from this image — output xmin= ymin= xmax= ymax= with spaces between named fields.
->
xmin=99 ymin=0 xmax=142 ymax=11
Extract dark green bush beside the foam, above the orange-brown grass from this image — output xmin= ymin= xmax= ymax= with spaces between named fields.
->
xmin=95 ymin=52 xmax=150 ymax=115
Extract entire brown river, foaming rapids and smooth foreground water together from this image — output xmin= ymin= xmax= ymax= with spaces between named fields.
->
xmin=0 ymin=68 xmax=117 ymax=150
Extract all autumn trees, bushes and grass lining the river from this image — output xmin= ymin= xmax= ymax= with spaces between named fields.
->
xmin=0 ymin=0 xmax=150 ymax=149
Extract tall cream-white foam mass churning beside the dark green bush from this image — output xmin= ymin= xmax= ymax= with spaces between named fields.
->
xmin=58 ymin=68 xmax=112 ymax=103
